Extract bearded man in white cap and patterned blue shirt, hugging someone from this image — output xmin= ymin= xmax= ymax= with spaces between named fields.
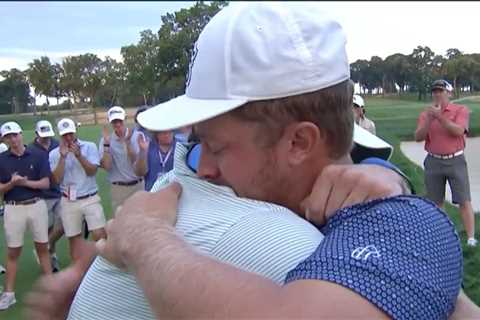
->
xmin=89 ymin=3 xmax=463 ymax=319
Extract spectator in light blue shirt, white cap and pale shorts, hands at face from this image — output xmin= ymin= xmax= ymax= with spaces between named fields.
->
xmin=49 ymin=118 xmax=106 ymax=261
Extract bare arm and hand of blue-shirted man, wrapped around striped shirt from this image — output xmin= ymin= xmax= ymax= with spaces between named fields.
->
xmin=97 ymin=184 xmax=386 ymax=318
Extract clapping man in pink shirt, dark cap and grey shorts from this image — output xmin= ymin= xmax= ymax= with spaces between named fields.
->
xmin=415 ymin=80 xmax=477 ymax=246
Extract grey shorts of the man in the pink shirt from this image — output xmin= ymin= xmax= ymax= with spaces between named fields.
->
xmin=423 ymin=154 xmax=471 ymax=205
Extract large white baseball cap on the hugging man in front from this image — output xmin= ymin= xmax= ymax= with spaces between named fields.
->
xmin=137 ymin=2 xmax=350 ymax=131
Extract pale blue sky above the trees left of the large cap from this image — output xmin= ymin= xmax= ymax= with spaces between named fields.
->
xmin=0 ymin=2 xmax=192 ymax=70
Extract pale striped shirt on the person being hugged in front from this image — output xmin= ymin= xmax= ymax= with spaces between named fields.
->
xmin=69 ymin=144 xmax=323 ymax=320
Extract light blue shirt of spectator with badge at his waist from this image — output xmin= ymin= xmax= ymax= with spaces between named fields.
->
xmin=49 ymin=139 xmax=100 ymax=197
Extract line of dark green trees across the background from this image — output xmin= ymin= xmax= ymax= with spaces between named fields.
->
xmin=0 ymin=1 xmax=480 ymax=122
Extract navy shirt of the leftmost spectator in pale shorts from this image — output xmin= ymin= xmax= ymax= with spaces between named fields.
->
xmin=0 ymin=148 xmax=50 ymax=201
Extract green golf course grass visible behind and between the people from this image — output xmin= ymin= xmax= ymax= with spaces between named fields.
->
xmin=0 ymin=97 xmax=480 ymax=320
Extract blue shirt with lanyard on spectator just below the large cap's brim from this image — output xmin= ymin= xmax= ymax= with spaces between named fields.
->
xmin=144 ymin=139 xmax=176 ymax=191
